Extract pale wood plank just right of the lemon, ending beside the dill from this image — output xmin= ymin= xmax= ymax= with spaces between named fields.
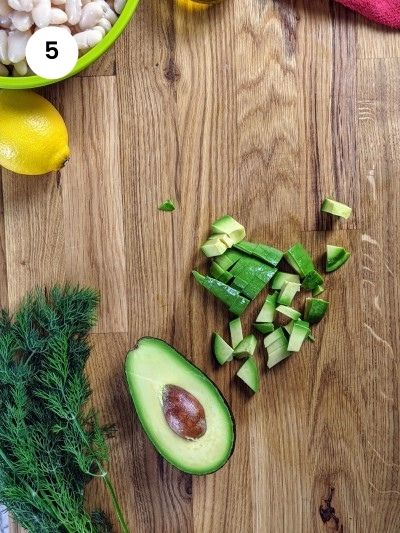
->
xmin=61 ymin=77 xmax=127 ymax=333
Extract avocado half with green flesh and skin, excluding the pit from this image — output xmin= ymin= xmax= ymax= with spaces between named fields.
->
xmin=125 ymin=337 xmax=235 ymax=475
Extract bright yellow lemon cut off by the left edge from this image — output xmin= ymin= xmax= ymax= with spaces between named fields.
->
xmin=0 ymin=90 xmax=69 ymax=176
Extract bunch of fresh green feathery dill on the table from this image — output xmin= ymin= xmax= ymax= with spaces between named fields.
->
xmin=0 ymin=286 xmax=128 ymax=533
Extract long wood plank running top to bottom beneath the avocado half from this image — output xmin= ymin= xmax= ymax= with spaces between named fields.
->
xmin=117 ymin=2 xmax=193 ymax=532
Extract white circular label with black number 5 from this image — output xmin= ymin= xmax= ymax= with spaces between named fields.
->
xmin=26 ymin=26 xmax=79 ymax=80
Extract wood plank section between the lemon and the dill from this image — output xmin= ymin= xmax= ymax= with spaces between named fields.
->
xmin=2 ymin=170 xmax=65 ymax=309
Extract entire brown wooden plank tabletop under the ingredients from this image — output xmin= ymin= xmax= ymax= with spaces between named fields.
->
xmin=0 ymin=0 xmax=400 ymax=533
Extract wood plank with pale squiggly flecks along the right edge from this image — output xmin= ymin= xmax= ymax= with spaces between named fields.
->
xmin=357 ymin=59 xmax=400 ymax=533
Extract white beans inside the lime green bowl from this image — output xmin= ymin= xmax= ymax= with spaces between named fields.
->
xmin=0 ymin=0 xmax=126 ymax=76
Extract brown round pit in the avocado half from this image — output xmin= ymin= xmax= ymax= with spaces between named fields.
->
xmin=162 ymin=385 xmax=207 ymax=440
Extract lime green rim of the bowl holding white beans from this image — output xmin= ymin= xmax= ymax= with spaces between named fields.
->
xmin=0 ymin=0 xmax=139 ymax=89
